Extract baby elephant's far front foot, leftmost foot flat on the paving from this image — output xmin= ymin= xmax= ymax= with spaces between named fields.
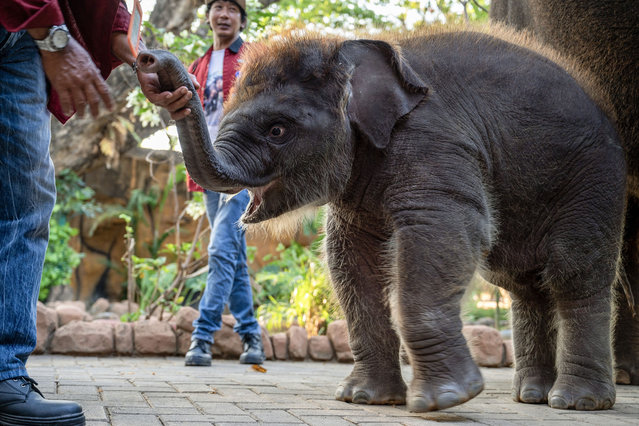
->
xmin=335 ymin=372 xmax=406 ymax=405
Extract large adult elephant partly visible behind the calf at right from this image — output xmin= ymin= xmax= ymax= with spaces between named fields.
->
xmin=490 ymin=0 xmax=639 ymax=385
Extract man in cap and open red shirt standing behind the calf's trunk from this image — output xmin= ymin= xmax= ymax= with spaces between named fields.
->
xmin=185 ymin=0 xmax=265 ymax=366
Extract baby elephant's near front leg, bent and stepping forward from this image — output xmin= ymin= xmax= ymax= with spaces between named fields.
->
xmin=391 ymin=210 xmax=484 ymax=412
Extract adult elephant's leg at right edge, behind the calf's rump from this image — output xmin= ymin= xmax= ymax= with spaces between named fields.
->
xmin=613 ymin=197 xmax=639 ymax=385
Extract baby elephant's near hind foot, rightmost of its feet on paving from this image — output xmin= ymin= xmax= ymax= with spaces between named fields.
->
xmin=548 ymin=374 xmax=616 ymax=411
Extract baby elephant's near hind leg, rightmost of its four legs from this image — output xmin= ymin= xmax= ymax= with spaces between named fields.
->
xmin=548 ymin=287 xmax=615 ymax=410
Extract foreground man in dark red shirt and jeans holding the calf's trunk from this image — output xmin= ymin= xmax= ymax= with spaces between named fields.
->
xmin=0 ymin=0 xmax=192 ymax=425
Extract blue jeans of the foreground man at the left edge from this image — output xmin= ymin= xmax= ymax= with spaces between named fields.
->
xmin=0 ymin=27 xmax=55 ymax=380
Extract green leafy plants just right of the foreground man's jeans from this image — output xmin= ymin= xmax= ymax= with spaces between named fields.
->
xmin=38 ymin=170 xmax=100 ymax=301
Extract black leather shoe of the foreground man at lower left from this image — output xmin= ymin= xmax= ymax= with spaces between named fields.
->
xmin=0 ymin=377 xmax=85 ymax=426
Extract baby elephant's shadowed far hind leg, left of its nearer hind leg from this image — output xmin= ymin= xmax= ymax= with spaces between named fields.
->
xmin=511 ymin=293 xmax=557 ymax=404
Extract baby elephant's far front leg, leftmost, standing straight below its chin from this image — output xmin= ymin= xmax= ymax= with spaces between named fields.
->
xmin=326 ymin=213 xmax=406 ymax=404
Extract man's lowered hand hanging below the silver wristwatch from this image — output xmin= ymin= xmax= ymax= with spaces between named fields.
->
xmin=40 ymin=38 xmax=113 ymax=117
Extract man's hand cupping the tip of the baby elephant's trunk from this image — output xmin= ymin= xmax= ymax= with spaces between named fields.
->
xmin=138 ymin=71 xmax=200 ymax=120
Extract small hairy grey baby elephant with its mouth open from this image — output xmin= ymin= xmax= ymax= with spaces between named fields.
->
xmin=168 ymin=32 xmax=626 ymax=411
